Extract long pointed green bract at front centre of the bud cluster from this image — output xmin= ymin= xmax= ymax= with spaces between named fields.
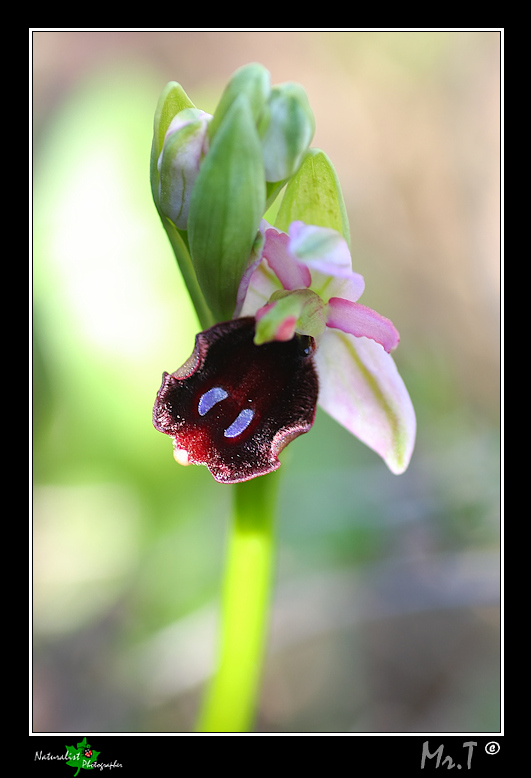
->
xmin=188 ymin=94 xmax=265 ymax=321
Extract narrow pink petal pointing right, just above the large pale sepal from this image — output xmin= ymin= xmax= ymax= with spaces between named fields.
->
xmin=326 ymin=297 xmax=400 ymax=353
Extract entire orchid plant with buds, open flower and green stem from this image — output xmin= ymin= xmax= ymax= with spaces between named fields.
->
xmin=150 ymin=63 xmax=415 ymax=732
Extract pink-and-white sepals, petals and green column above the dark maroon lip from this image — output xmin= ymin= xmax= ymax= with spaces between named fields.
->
xmin=235 ymin=221 xmax=416 ymax=474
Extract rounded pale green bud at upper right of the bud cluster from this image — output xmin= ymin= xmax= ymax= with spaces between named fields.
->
xmin=258 ymin=83 xmax=315 ymax=181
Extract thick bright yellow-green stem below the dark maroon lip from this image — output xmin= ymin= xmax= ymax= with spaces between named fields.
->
xmin=197 ymin=473 xmax=279 ymax=732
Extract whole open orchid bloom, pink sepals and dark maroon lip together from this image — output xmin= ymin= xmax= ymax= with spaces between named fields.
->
xmin=153 ymin=221 xmax=415 ymax=483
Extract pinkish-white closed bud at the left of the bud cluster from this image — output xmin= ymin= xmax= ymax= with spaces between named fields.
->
xmin=157 ymin=108 xmax=212 ymax=230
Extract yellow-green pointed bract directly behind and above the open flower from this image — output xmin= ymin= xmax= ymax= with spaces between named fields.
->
xmin=275 ymin=149 xmax=350 ymax=245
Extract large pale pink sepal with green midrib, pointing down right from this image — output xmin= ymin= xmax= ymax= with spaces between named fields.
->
xmin=315 ymin=329 xmax=416 ymax=475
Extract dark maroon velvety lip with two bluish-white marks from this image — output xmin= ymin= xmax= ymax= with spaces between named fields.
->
xmin=153 ymin=317 xmax=318 ymax=484
